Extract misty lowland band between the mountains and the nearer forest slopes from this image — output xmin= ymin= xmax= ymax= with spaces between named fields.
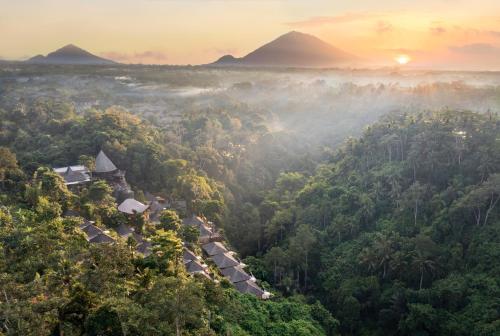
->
xmin=0 ymin=66 xmax=500 ymax=145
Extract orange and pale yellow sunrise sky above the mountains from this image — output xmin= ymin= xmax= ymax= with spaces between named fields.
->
xmin=0 ymin=0 xmax=500 ymax=70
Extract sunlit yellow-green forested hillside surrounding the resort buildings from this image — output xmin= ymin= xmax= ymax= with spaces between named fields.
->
xmin=0 ymin=100 xmax=338 ymax=336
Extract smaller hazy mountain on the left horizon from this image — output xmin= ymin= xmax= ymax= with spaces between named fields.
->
xmin=26 ymin=44 xmax=116 ymax=65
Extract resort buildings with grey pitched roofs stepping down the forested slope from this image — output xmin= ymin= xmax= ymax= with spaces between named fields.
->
xmin=54 ymin=151 xmax=271 ymax=299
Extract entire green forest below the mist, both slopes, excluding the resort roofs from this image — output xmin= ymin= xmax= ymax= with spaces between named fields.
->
xmin=0 ymin=92 xmax=500 ymax=335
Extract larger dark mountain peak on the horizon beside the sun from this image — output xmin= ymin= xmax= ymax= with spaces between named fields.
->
xmin=212 ymin=31 xmax=359 ymax=67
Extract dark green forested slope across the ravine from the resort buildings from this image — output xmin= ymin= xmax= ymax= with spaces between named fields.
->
xmin=237 ymin=111 xmax=500 ymax=335
